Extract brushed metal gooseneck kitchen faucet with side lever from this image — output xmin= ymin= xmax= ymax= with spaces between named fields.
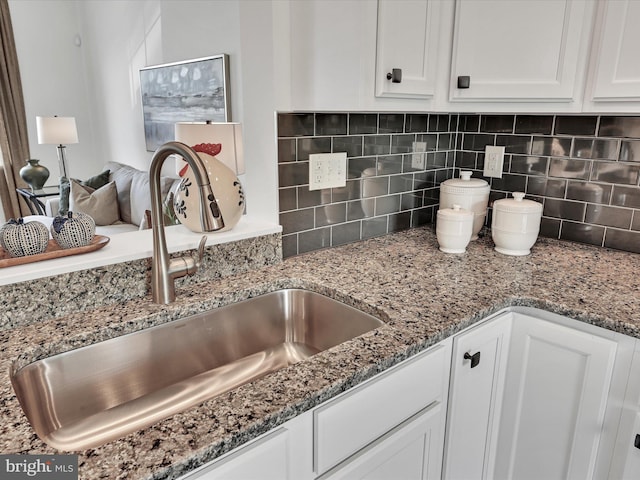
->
xmin=149 ymin=142 xmax=224 ymax=304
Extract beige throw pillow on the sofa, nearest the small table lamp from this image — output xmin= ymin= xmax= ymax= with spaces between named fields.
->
xmin=69 ymin=179 xmax=120 ymax=225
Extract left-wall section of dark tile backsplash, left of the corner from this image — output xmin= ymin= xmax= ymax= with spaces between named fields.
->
xmin=278 ymin=113 xmax=457 ymax=257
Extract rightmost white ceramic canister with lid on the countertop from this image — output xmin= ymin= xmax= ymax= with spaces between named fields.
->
xmin=491 ymin=192 xmax=542 ymax=255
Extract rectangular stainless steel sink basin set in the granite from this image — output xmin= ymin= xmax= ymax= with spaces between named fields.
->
xmin=11 ymin=289 xmax=383 ymax=451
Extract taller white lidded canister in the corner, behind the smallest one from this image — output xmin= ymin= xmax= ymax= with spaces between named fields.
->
xmin=440 ymin=170 xmax=491 ymax=240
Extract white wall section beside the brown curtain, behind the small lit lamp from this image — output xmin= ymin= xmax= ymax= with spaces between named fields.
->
xmin=9 ymin=0 xmax=104 ymax=181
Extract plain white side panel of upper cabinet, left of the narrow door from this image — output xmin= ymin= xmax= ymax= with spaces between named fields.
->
xmin=282 ymin=0 xmax=377 ymax=111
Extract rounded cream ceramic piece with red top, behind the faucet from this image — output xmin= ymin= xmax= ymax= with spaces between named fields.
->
xmin=173 ymin=144 xmax=244 ymax=233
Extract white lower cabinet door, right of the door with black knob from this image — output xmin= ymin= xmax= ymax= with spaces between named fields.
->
xmin=490 ymin=313 xmax=617 ymax=480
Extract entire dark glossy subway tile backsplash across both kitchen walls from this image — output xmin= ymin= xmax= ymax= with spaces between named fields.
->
xmin=278 ymin=113 xmax=640 ymax=257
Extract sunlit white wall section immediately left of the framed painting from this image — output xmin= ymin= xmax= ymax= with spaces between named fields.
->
xmin=78 ymin=1 xmax=154 ymax=170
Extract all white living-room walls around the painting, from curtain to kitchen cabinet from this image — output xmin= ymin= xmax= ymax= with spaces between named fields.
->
xmin=10 ymin=0 xmax=288 ymax=223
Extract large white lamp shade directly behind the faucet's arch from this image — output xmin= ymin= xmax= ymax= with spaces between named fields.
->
xmin=175 ymin=122 xmax=245 ymax=175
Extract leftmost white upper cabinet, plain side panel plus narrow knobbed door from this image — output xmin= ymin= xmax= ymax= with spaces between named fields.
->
xmin=277 ymin=0 xmax=453 ymax=111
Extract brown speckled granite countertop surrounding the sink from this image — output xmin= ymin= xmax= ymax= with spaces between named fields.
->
xmin=0 ymin=228 xmax=640 ymax=479
